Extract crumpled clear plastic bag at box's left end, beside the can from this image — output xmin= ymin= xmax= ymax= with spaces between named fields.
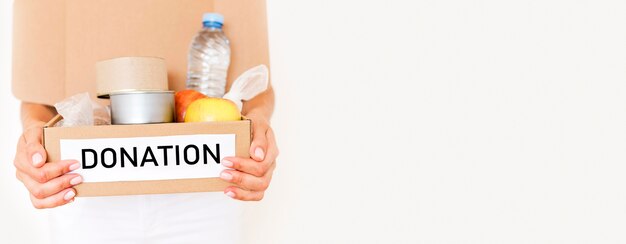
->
xmin=54 ymin=93 xmax=111 ymax=127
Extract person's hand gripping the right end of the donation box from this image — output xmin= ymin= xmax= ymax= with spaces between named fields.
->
xmin=220 ymin=114 xmax=278 ymax=201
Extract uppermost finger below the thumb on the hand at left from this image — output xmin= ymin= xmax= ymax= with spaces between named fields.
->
xmin=16 ymin=160 xmax=80 ymax=183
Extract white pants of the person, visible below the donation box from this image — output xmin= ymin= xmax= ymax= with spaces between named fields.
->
xmin=50 ymin=192 xmax=242 ymax=244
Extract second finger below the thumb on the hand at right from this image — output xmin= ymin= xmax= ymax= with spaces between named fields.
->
xmin=220 ymin=164 xmax=275 ymax=191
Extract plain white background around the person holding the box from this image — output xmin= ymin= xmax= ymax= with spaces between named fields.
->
xmin=0 ymin=0 xmax=626 ymax=244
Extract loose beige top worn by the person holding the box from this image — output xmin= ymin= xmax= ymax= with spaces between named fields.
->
xmin=13 ymin=0 xmax=269 ymax=105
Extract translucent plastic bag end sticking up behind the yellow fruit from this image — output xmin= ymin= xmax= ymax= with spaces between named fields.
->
xmin=222 ymin=65 xmax=269 ymax=111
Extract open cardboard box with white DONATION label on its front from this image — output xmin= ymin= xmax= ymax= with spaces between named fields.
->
xmin=44 ymin=116 xmax=251 ymax=197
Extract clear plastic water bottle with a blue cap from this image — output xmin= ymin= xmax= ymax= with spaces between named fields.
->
xmin=187 ymin=13 xmax=230 ymax=97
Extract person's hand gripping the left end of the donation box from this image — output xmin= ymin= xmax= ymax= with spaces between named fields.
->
xmin=13 ymin=124 xmax=83 ymax=209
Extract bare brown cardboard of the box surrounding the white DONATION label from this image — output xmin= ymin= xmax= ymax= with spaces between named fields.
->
xmin=44 ymin=115 xmax=252 ymax=197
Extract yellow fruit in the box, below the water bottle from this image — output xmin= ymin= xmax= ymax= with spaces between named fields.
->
xmin=185 ymin=97 xmax=241 ymax=122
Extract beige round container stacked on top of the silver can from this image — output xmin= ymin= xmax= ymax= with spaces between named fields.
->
xmin=96 ymin=57 xmax=169 ymax=98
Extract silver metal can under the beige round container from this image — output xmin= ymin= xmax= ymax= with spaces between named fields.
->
xmin=110 ymin=91 xmax=175 ymax=125
